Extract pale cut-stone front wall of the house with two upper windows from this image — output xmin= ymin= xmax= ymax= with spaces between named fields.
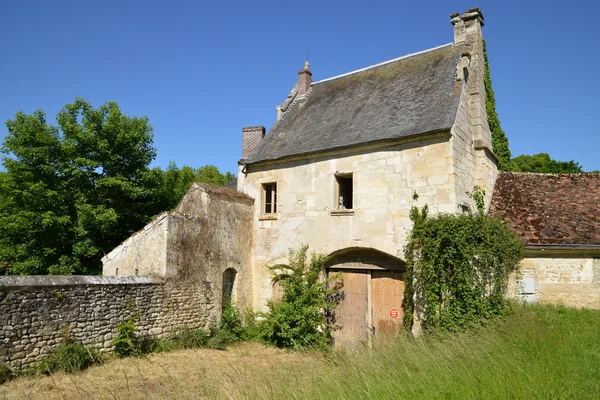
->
xmin=238 ymin=136 xmax=457 ymax=310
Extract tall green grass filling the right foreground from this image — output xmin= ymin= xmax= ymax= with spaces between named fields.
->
xmin=229 ymin=305 xmax=600 ymax=399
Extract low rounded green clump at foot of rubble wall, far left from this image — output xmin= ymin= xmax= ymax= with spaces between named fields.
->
xmin=38 ymin=341 xmax=102 ymax=375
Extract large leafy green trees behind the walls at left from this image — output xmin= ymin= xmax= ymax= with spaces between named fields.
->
xmin=0 ymin=98 xmax=233 ymax=275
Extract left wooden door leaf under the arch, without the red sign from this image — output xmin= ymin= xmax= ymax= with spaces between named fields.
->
xmin=333 ymin=271 xmax=370 ymax=347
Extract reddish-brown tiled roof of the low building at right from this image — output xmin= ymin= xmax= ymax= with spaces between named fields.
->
xmin=490 ymin=172 xmax=600 ymax=245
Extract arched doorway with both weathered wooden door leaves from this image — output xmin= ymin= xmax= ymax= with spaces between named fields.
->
xmin=326 ymin=249 xmax=406 ymax=346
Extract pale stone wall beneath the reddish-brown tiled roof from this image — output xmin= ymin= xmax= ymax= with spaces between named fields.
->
xmin=508 ymin=254 xmax=600 ymax=309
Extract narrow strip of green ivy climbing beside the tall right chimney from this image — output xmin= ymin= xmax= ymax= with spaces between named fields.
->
xmin=483 ymin=40 xmax=511 ymax=171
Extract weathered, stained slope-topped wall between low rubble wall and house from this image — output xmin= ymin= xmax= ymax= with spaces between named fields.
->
xmin=102 ymin=183 xmax=254 ymax=312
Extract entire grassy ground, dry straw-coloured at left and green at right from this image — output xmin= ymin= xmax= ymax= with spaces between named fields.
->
xmin=0 ymin=306 xmax=600 ymax=400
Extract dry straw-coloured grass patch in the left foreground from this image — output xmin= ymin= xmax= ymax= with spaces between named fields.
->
xmin=0 ymin=342 xmax=321 ymax=400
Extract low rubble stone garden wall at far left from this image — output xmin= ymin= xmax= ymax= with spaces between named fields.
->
xmin=0 ymin=276 xmax=214 ymax=368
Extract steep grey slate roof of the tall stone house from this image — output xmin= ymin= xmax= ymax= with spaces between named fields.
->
xmin=246 ymin=44 xmax=460 ymax=164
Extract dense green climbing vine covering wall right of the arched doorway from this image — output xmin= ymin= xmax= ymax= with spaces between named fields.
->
xmin=404 ymin=189 xmax=523 ymax=328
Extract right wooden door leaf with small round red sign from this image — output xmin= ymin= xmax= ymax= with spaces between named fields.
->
xmin=371 ymin=271 xmax=404 ymax=337
